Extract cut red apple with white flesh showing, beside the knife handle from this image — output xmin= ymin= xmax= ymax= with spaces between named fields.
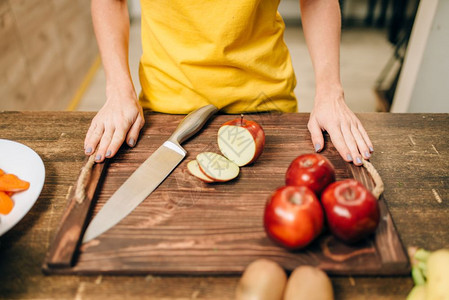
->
xmin=218 ymin=115 xmax=265 ymax=167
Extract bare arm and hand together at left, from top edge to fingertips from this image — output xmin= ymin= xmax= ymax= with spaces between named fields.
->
xmin=84 ymin=0 xmax=145 ymax=162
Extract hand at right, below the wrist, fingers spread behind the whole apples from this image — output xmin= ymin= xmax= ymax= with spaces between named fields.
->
xmin=307 ymin=89 xmax=374 ymax=166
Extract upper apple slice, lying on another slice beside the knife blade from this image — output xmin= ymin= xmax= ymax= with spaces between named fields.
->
xmin=196 ymin=152 xmax=240 ymax=182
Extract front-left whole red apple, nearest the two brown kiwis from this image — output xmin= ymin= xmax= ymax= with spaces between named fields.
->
xmin=264 ymin=186 xmax=324 ymax=250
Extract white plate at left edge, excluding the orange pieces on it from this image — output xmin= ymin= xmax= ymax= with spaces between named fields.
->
xmin=0 ymin=139 xmax=45 ymax=236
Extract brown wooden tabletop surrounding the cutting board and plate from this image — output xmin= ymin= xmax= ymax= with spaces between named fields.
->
xmin=0 ymin=112 xmax=449 ymax=299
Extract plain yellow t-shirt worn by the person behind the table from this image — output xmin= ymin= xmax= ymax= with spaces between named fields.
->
xmin=139 ymin=0 xmax=297 ymax=114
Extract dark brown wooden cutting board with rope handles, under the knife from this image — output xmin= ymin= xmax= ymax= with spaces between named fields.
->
xmin=43 ymin=113 xmax=410 ymax=275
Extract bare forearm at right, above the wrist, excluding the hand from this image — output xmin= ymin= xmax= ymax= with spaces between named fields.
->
xmin=300 ymin=0 xmax=341 ymax=92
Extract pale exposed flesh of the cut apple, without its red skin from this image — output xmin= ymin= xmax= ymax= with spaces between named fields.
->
xmin=218 ymin=125 xmax=257 ymax=167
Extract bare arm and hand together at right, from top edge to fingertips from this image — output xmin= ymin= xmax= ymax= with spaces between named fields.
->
xmin=300 ymin=0 xmax=373 ymax=166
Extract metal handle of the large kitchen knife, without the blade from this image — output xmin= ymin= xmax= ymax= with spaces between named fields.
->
xmin=168 ymin=104 xmax=218 ymax=145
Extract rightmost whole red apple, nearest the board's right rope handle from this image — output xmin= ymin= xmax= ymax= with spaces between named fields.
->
xmin=321 ymin=179 xmax=380 ymax=243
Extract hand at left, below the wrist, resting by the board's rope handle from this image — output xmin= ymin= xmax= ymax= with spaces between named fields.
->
xmin=84 ymin=89 xmax=145 ymax=162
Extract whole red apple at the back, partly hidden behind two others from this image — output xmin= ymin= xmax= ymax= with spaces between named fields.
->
xmin=285 ymin=153 xmax=335 ymax=195
